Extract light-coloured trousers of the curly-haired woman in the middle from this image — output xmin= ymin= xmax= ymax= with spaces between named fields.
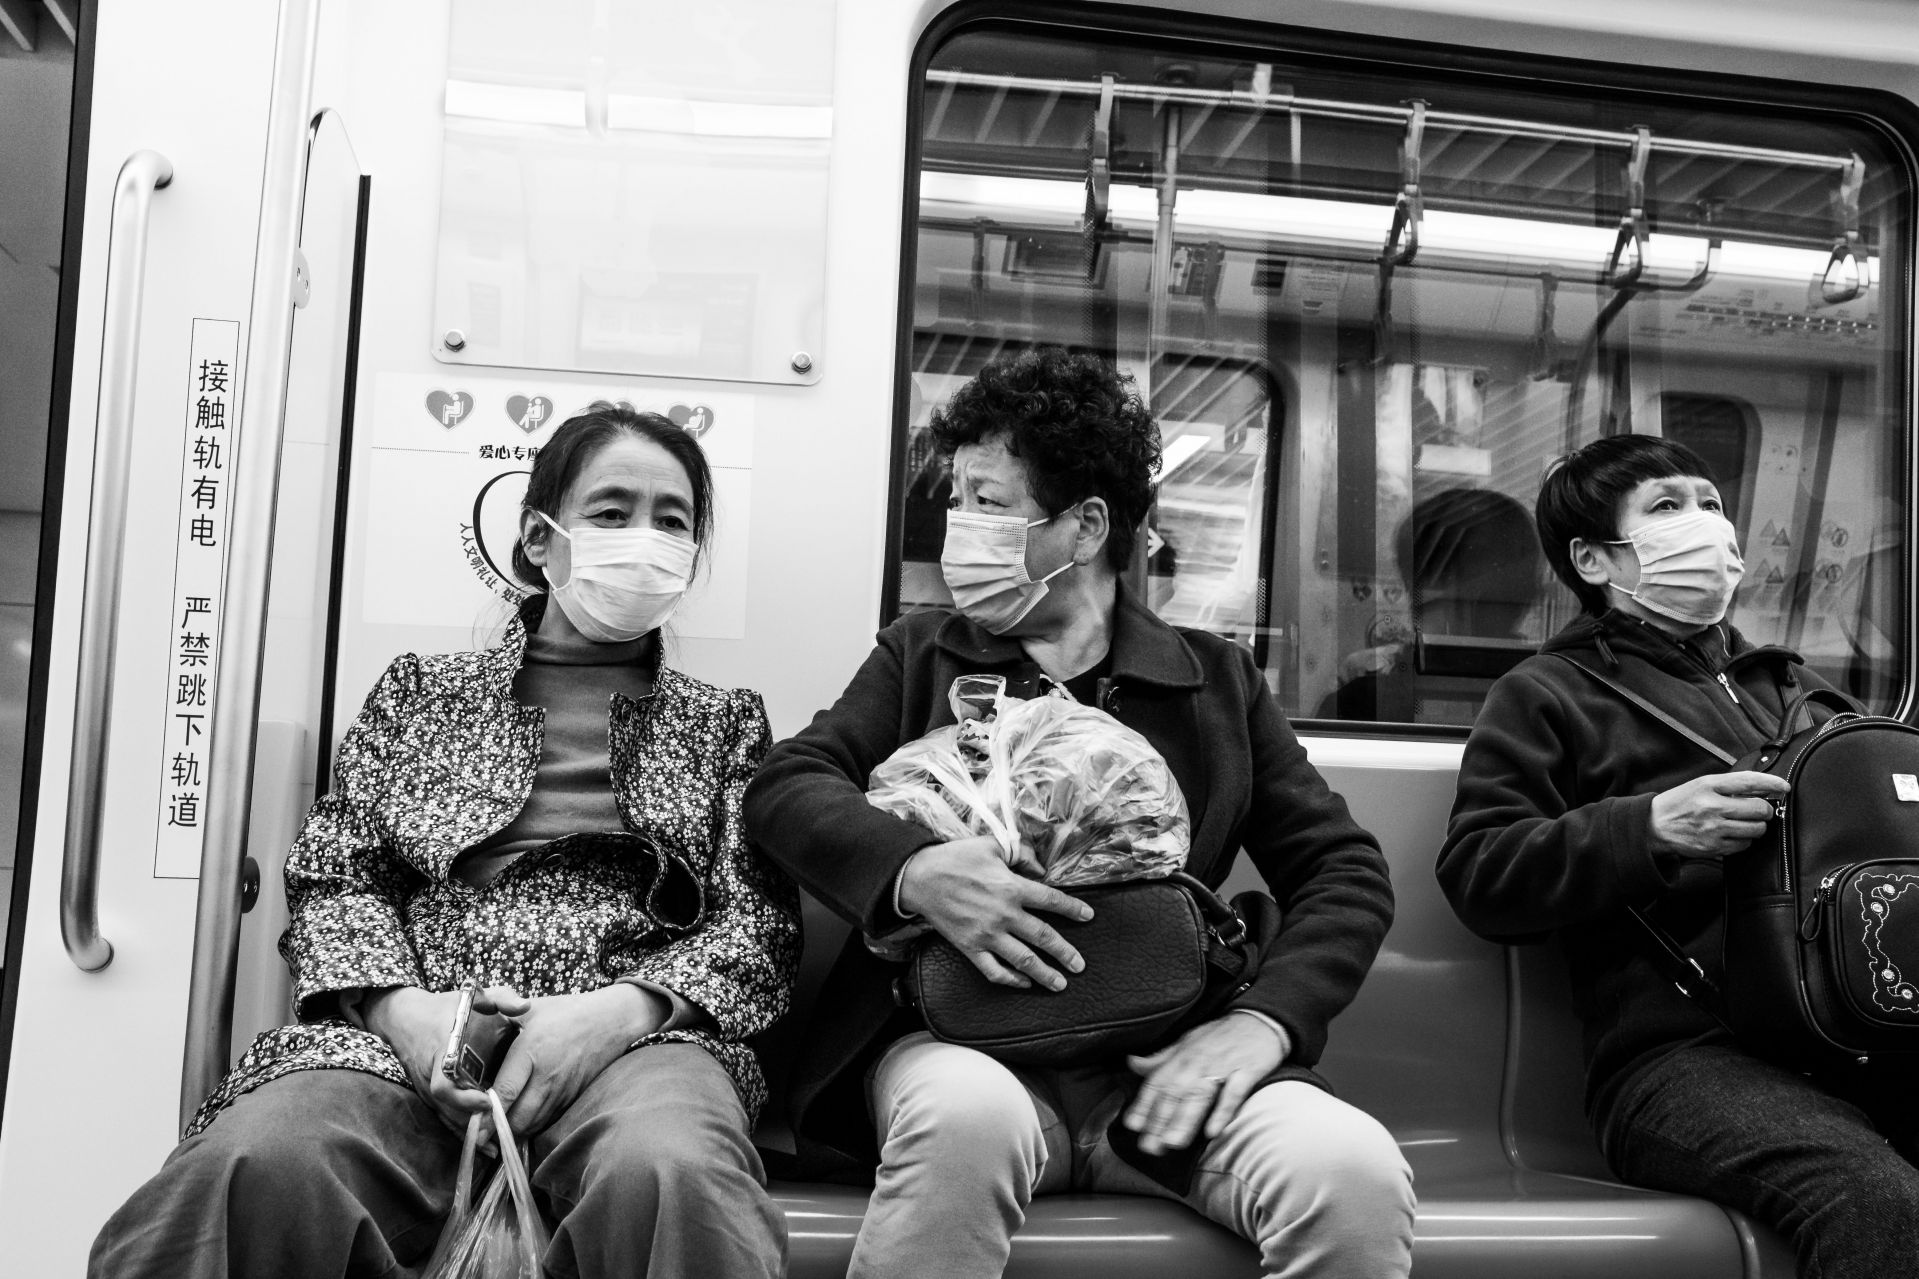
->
xmin=848 ymin=1031 xmax=1414 ymax=1279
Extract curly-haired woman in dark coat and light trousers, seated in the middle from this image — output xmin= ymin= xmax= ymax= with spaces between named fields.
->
xmin=746 ymin=351 xmax=1412 ymax=1279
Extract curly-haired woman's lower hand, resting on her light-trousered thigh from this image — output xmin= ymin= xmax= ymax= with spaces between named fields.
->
xmin=1123 ymin=1012 xmax=1291 ymax=1154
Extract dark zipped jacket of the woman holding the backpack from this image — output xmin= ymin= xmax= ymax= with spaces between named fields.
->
xmin=1439 ymin=613 xmax=1827 ymax=1123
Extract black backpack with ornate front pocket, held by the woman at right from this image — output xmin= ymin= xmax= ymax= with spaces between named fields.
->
xmin=1560 ymin=655 xmax=1919 ymax=1068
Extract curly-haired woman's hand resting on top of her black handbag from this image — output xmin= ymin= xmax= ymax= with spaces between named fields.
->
xmin=900 ymin=835 xmax=1092 ymax=991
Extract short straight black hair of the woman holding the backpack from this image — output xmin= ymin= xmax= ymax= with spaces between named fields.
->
xmin=1533 ymin=436 xmax=1718 ymax=613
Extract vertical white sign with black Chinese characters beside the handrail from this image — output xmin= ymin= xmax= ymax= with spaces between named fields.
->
xmin=154 ymin=319 xmax=240 ymax=880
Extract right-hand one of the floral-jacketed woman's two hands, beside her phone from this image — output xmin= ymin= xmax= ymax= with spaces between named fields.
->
xmin=474 ymin=981 xmax=674 ymax=1139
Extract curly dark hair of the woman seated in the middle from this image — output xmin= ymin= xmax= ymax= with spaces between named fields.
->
xmin=933 ymin=346 xmax=1159 ymax=570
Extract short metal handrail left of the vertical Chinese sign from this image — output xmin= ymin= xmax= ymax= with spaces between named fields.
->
xmin=59 ymin=152 xmax=173 ymax=972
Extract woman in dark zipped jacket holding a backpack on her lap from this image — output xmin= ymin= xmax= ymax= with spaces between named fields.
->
xmin=1439 ymin=436 xmax=1919 ymax=1279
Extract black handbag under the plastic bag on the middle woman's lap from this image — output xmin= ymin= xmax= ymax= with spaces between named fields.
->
xmin=894 ymin=872 xmax=1278 ymax=1066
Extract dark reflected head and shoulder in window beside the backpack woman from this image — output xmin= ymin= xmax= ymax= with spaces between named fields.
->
xmin=1318 ymin=488 xmax=1539 ymax=724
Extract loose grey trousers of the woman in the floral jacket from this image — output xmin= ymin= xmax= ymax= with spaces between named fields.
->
xmin=88 ymin=1043 xmax=787 ymax=1279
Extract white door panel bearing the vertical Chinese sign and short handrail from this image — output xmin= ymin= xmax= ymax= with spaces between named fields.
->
xmin=0 ymin=0 xmax=293 ymax=1275
